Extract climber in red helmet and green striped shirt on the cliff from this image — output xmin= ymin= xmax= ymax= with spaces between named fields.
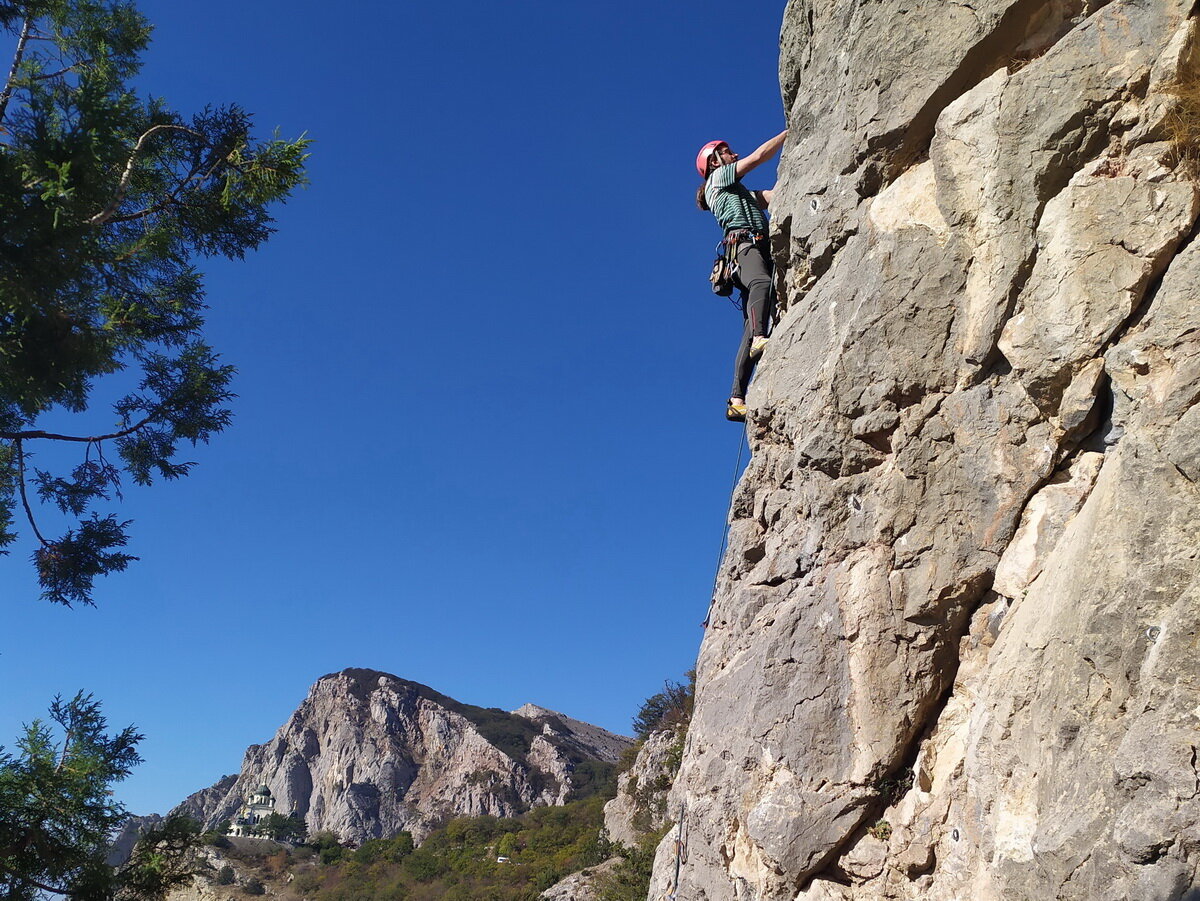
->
xmin=696 ymin=131 xmax=787 ymax=422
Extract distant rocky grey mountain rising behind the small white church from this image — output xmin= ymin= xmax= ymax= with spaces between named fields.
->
xmin=176 ymin=669 xmax=631 ymax=843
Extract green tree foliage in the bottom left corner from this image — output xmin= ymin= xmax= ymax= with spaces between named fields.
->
xmin=0 ymin=693 xmax=199 ymax=901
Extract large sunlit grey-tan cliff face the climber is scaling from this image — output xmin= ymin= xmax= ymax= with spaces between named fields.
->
xmin=652 ymin=0 xmax=1200 ymax=901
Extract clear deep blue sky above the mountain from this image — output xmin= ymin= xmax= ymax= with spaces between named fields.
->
xmin=0 ymin=0 xmax=785 ymax=813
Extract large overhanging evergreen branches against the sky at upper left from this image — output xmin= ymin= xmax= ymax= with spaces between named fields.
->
xmin=0 ymin=0 xmax=308 ymax=605
